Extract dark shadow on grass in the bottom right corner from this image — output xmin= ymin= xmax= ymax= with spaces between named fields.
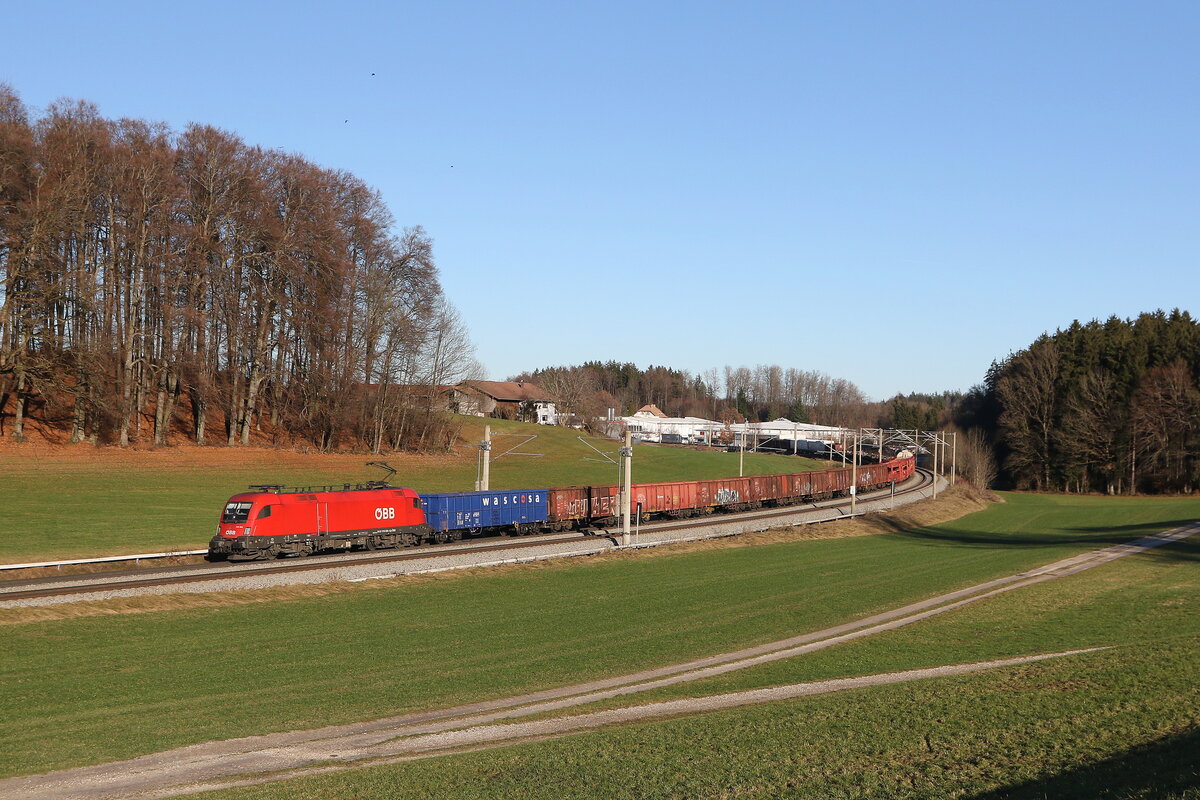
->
xmin=968 ymin=728 xmax=1200 ymax=800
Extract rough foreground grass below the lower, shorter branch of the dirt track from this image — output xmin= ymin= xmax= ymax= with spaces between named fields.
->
xmin=200 ymin=642 xmax=1200 ymax=800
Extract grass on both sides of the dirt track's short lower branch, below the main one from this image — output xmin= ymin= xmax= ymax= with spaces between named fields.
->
xmin=194 ymin=503 xmax=1200 ymax=800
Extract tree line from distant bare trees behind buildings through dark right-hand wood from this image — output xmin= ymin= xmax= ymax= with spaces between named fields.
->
xmin=521 ymin=309 xmax=1200 ymax=494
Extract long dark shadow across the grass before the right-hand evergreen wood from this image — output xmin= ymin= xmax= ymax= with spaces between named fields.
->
xmin=876 ymin=517 xmax=1200 ymax=561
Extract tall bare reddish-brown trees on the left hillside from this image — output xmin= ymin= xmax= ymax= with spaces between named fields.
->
xmin=0 ymin=84 xmax=479 ymax=451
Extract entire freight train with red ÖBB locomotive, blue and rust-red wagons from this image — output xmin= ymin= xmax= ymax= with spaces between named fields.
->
xmin=208 ymin=452 xmax=914 ymax=560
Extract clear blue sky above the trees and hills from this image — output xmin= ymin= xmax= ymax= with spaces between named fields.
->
xmin=0 ymin=0 xmax=1200 ymax=398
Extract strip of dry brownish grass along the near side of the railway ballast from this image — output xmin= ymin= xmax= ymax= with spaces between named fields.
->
xmin=0 ymin=484 xmax=998 ymax=626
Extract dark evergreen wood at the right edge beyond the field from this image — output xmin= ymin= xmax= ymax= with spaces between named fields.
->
xmin=955 ymin=309 xmax=1200 ymax=494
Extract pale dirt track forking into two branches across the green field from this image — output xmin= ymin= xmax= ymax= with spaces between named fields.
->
xmin=0 ymin=525 xmax=1200 ymax=800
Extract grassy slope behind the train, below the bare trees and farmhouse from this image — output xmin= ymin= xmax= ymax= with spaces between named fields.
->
xmin=0 ymin=417 xmax=828 ymax=564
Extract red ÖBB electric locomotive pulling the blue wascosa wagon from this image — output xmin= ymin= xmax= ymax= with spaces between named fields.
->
xmin=208 ymin=482 xmax=433 ymax=560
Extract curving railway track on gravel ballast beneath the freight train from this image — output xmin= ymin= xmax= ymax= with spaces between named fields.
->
xmin=0 ymin=469 xmax=934 ymax=603
